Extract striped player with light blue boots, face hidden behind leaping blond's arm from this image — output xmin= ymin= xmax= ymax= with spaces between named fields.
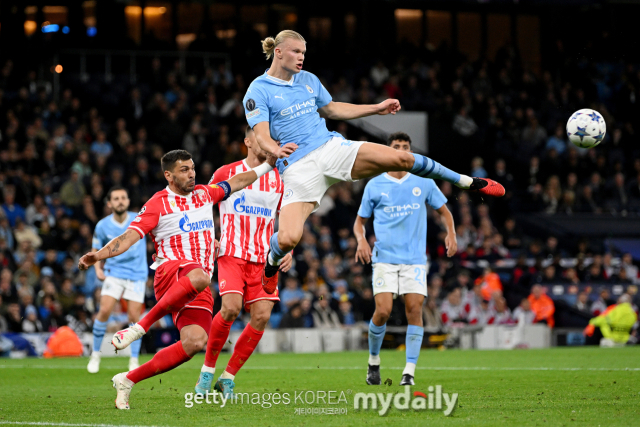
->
xmin=196 ymin=127 xmax=291 ymax=398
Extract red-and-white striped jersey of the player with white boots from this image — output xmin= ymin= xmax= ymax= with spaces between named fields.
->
xmin=128 ymin=182 xmax=230 ymax=276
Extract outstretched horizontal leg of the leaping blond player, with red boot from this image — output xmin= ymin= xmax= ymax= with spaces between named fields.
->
xmin=351 ymin=144 xmax=505 ymax=197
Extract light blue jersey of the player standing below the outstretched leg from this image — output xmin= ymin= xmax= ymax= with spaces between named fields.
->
xmin=358 ymin=173 xmax=447 ymax=264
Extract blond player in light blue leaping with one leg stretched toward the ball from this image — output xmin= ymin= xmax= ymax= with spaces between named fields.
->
xmin=243 ymin=30 xmax=504 ymax=293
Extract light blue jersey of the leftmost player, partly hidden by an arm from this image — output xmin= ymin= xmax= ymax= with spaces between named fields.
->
xmin=91 ymin=212 xmax=149 ymax=281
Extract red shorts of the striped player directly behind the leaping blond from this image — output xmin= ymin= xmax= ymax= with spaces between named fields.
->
xmin=218 ymin=255 xmax=280 ymax=311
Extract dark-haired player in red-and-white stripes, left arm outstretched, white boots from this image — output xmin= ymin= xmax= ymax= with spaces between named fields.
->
xmin=78 ymin=150 xmax=282 ymax=409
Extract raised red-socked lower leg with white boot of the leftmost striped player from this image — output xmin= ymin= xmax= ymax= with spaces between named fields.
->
xmin=111 ymin=266 xmax=211 ymax=350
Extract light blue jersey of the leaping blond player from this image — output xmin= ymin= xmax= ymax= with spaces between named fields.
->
xmin=242 ymin=70 xmax=342 ymax=173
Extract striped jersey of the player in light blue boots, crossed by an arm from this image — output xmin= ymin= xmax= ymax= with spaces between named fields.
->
xmin=210 ymin=160 xmax=284 ymax=263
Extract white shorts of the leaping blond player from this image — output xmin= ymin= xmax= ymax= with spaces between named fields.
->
xmin=281 ymin=137 xmax=369 ymax=212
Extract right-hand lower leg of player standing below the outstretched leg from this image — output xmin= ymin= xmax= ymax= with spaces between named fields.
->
xmin=400 ymin=293 xmax=424 ymax=385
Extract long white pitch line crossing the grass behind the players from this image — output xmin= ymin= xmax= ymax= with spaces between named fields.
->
xmin=0 ymin=365 xmax=640 ymax=371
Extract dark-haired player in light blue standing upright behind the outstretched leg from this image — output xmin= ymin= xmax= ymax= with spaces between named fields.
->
xmin=353 ymin=132 xmax=458 ymax=385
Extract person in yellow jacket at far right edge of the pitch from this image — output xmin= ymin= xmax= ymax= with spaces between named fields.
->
xmin=584 ymin=294 xmax=638 ymax=347
